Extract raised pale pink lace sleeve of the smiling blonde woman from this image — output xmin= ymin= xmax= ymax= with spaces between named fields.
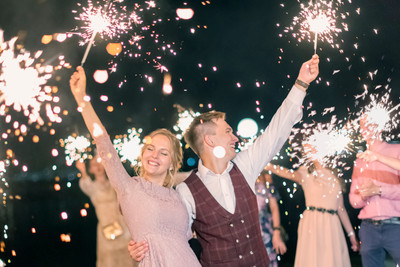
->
xmin=94 ymin=134 xmax=131 ymax=193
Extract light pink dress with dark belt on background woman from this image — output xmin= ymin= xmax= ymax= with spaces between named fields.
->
xmin=294 ymin=167 xmax=351 ymax=267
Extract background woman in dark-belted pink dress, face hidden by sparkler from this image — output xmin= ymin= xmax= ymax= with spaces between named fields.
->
xmin=266 ymin=149 xmax=359 ymax=267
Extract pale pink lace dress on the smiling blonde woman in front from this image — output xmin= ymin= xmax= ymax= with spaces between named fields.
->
xmin=95 ymin=135 xmax=200 ymax=267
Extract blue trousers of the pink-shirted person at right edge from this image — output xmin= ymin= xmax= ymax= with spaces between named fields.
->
xmin=359 ymin=221 xmax=400 ymax=267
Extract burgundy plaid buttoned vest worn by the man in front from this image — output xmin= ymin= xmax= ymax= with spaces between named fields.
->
xmin=185 ymin=165 xmax=269 ymax=267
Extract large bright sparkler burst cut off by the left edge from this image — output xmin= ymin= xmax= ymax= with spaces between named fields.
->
xmin=0 ymin=30 xmax=65 ymax=125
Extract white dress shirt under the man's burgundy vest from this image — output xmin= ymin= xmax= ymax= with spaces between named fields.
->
xmin=176 ymin=86 xmax=306 ymax=232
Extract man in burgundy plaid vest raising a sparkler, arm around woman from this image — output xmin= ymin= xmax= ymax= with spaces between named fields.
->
xmin=129 ymin=55 xmax=319 ymax=267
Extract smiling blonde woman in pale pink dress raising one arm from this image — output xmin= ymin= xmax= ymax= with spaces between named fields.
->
xmin=70 ymin=67 xmax=200 ymax=267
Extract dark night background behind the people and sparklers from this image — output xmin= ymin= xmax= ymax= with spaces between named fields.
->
xmin=0 ymin=0 xmax=400 ymax=266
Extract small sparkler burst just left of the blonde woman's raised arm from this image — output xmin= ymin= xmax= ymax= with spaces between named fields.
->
xmin=60 ymin=136 xmax=91 ymax=166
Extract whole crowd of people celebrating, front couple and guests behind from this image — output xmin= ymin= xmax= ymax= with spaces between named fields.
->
xmin=70 ymin=52 xmax=400 ymax=267
